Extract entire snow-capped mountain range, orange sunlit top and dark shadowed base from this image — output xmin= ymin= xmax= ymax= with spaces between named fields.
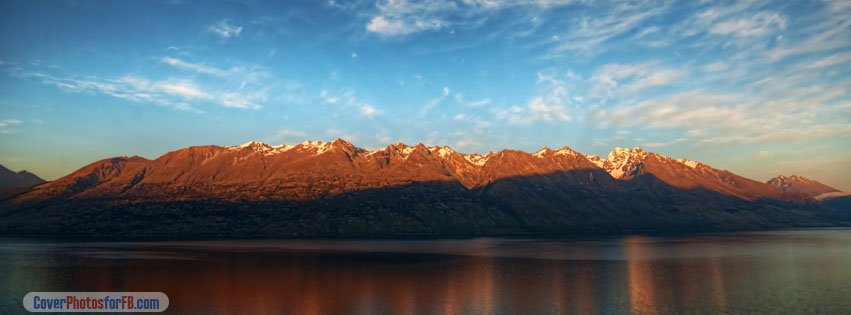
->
xmin=0 ymin=139 xmax=851 ymax=237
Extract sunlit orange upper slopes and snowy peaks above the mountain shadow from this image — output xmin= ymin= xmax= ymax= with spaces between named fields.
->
xmin=5 ymin=138 xmax=824 ymax=204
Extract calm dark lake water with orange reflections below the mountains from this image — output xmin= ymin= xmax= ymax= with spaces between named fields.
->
xmin=0 ymin=229 xmax=851 ymax=314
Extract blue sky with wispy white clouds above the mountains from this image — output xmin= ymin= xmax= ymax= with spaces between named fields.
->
xmin=0 ymin=0 xmax=851 ymax=191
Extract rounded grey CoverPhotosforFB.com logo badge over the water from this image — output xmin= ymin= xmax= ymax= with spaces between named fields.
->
xmin=24 ymin=292 xmax=168 ymax=313
